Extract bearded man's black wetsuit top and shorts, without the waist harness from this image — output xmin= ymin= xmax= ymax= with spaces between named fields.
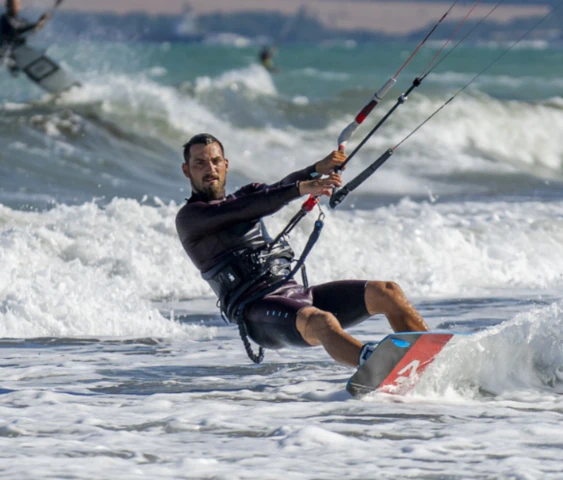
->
xmin=176 ymin=166 xmax=369 ymax=348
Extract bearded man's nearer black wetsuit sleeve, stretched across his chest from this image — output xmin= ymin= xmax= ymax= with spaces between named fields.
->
xmin=176 ymin=183 xmax=300 ymax=241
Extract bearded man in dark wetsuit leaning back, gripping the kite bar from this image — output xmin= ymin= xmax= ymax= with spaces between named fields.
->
xmin=176 ymin=133 xmax=428 ymax=367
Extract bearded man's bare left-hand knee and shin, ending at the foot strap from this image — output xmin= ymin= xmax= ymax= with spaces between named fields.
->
xmin=297 ymin=307 xmax=363 ymax=367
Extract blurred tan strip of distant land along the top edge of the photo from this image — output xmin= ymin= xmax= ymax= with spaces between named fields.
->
xmin=64 ymin=0 xmax=550 ymax=35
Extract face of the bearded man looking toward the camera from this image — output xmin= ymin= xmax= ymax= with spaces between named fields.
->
xmin=182 ymin=143 xmax=229 ymax=200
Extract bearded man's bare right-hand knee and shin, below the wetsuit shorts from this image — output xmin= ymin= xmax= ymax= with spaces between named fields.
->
xmin=365 ymin=282 xmax=429 ymax=332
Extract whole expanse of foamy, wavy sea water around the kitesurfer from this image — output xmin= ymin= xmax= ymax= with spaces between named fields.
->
xmin=0 ymin=35 xmax=563 ymax=479
